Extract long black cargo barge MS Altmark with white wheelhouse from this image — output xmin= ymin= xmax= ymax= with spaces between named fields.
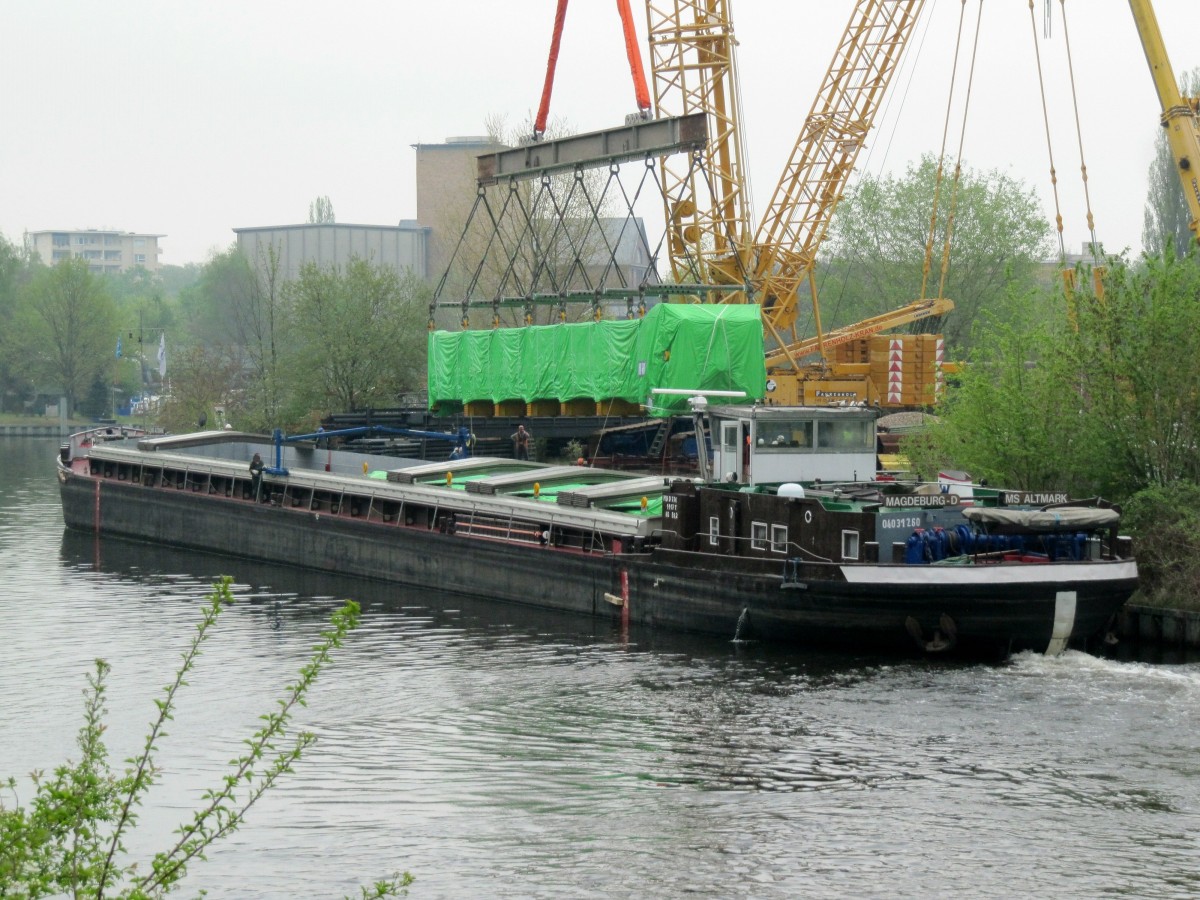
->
xmin=58 ymin=406 xmax=1138 ymax=654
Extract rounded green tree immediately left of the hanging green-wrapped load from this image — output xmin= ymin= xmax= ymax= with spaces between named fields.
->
xmin=286 ymin=257 xmax=428 ymax=413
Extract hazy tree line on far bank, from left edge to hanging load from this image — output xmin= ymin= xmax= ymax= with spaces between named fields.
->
xmin=0 ymin=236 xmax=430 ymax=431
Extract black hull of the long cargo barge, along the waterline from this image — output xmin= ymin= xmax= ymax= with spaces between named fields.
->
xmin=60 ymin=468 xmax=1136 ymax=654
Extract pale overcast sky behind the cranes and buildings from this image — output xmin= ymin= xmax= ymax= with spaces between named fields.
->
xmin=0 ymin=0 xmax=1200 ymax=264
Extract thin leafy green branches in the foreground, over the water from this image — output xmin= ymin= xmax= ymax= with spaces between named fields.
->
xmin=0 ymin=578 xmax=413 ymax=899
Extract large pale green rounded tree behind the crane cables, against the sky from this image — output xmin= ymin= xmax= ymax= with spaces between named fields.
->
xmin=818 ymin=156 xmax=1050 ymax=353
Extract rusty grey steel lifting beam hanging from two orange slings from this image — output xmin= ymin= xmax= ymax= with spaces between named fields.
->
xmin=476 ymin=113 xmax=708 ymax=187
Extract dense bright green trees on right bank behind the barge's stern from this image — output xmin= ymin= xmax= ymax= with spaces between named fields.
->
xmin=905 ymin=251 xmax=1200 ymax=500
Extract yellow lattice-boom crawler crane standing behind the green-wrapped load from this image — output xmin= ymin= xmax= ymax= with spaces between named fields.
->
xmin=647 ymin=0 xmax=954 ymax=407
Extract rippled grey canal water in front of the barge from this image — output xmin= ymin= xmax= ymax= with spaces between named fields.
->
xmin=0 ymin=439 xmax=1200 ymax=898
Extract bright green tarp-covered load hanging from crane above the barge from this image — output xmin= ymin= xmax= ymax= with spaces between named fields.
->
xmin=428 ymin=304 xmax=767 ymax=415
